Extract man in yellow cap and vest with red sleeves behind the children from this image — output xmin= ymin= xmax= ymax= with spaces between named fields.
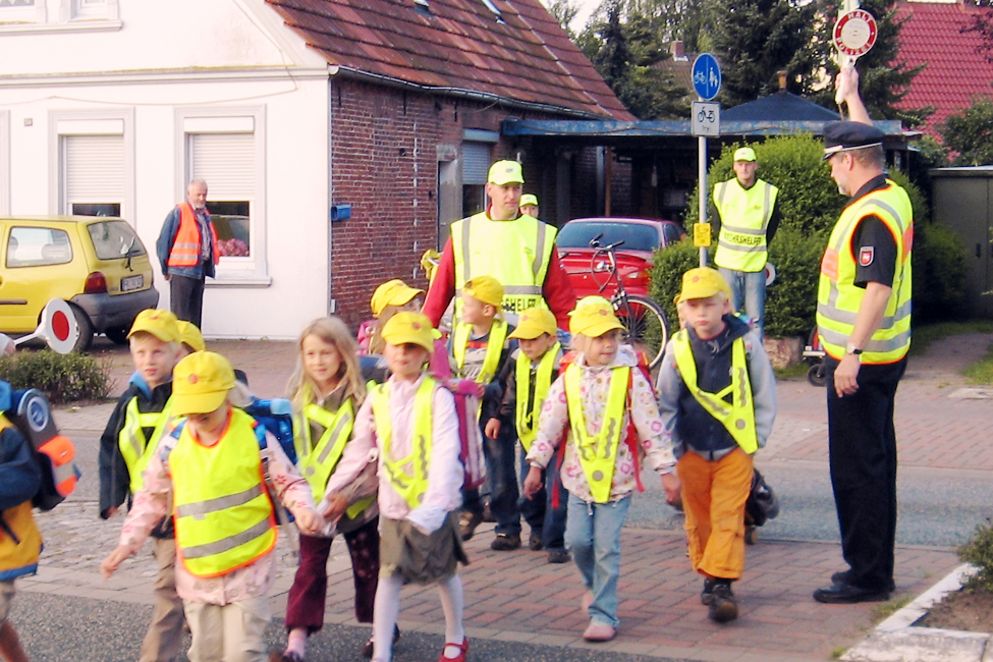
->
xmin=424 ymin=161 xmax=576 ymax=329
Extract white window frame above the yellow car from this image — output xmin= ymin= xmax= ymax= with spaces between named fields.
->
xmin=48 ymin=108 xmax=137 ymax=227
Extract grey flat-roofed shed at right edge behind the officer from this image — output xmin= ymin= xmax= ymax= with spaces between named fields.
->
xmin=930 ymin=166 xmax=993 ymax=318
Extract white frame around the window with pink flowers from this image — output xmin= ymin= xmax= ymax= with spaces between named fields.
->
xmin=175 ymin=106 xmax=272 ymax=287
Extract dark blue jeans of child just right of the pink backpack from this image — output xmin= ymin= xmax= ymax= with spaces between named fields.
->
xmin=462 ymin=421 xmax=521 ymax=536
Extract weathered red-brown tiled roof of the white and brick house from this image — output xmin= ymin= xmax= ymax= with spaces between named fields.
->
xmin=266 ymin=0 xmax=633 ymax=120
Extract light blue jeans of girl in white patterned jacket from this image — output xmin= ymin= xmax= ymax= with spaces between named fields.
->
xmin=565 ymin=494 xmax=631 ymax=628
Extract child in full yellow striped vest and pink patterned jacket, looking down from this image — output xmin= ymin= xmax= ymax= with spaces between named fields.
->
xmin=100 ymin=351 xmax=323 ymax=662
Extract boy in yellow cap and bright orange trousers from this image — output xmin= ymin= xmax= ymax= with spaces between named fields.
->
xmin=659 ymin=267 xmax=776 ymax=623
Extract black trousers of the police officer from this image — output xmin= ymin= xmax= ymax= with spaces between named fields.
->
xmin=825 ymin=357 xmax=907 ymax=591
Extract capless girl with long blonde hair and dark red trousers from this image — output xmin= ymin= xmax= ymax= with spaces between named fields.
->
xmin=283 ymin=317 xmax=379 ymax=662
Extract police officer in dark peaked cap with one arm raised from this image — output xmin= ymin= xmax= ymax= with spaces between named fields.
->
xmin=814 ymin=67 xmax=914 ymax=603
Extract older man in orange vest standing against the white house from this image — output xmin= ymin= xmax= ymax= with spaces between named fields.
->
xmin=155 ymin=179 xmax=220 ymax=328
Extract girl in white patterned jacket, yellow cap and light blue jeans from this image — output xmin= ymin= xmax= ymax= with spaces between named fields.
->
xmin=524 ymin=296 xmax=679 ymax=642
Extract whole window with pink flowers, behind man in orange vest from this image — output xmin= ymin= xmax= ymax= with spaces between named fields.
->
xmin=179 ymin=108 xmax=268 ymax=283
